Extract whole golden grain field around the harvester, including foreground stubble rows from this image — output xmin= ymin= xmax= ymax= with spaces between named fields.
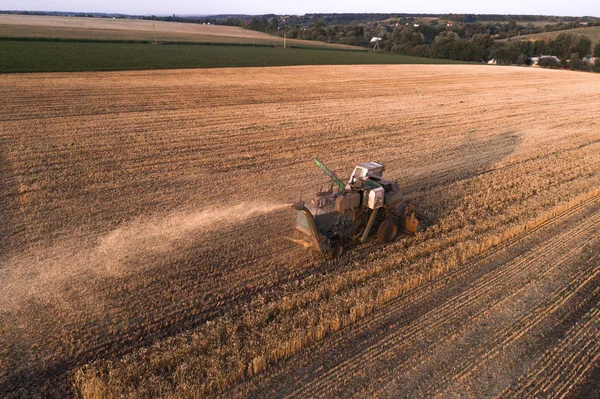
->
xmin=0 ymin=65 xmax=600 ymax=398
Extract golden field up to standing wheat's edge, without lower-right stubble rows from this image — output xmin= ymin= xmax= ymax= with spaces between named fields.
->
xmin=0 ymin=65 xmax=600 ymax=396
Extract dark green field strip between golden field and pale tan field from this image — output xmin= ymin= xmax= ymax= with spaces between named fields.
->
xmin=0 ymin=40 xmax=466 ymax=73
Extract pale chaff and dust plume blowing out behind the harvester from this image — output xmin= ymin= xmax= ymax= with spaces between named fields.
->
xmin=0 ymin=203 xmax=289 ymax=313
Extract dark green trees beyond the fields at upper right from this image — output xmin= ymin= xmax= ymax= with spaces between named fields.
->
xmin=238 ymin=16 xmax=600 ymax=72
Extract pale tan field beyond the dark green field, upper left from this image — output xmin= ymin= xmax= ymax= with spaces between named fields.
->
xmin=0 ymin=14 xmax=364 ymax=51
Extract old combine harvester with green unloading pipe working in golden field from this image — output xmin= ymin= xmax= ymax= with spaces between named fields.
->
xmin=292 ymin=158 xmax=424 ymax=258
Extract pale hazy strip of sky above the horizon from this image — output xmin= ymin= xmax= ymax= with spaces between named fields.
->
xmin=0 ymin=0 xmax=600 ymax=17
